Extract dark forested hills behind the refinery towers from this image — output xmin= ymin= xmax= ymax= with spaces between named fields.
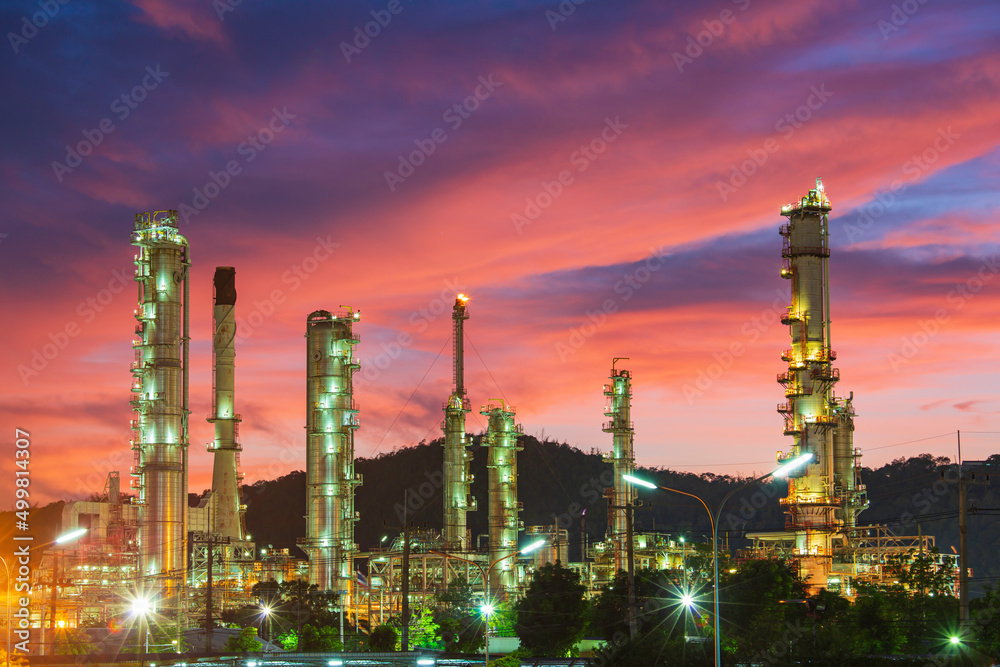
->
xmin=244 ymin=436 xmax=1000 ymax=587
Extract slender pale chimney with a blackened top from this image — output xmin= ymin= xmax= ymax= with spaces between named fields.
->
xmin=208 ymin=266 xmax=243 ymax=540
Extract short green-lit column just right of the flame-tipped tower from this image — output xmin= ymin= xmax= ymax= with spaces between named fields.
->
xmin=479 ymin=399 xmax=524 ymax=598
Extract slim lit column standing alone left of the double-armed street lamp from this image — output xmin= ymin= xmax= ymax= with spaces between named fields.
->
xmin=603 ymin=359 xmax=636 ymax=572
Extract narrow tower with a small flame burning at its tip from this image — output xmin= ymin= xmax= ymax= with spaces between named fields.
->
xmin=443 ymin=294 xmax=476 ymax=551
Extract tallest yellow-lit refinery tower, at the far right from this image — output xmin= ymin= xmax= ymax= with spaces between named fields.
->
xmin=778 ymin=179 xmax=842 ymax=586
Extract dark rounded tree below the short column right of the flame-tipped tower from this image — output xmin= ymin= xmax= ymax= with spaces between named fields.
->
xmin=514 ymin=563 xmax=589 ymax=657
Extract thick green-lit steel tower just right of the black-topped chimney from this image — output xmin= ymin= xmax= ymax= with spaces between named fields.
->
xmin=302 ymin=308 xmax=361 ymax=601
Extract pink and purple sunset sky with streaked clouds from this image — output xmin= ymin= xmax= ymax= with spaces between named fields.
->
xmin=0 ymin=0 xmax=1000 ymax=506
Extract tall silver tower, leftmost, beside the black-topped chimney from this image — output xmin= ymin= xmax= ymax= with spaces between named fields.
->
xmin=130 ymin=210 xmax=191 ymax=591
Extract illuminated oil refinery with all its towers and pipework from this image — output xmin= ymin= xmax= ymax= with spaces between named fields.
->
xmin=30 ymin=179 xmax=953 ymax=664
